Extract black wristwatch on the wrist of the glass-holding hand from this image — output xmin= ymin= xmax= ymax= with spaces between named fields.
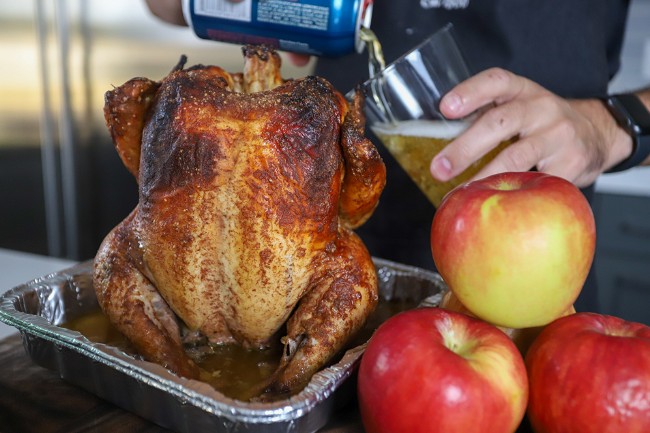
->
xmin=604 ymin=93 xmax=650 ymax=173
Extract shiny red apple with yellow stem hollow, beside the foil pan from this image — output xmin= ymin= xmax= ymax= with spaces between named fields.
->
xmin=358 ymin=308 xmax=528 ymax=433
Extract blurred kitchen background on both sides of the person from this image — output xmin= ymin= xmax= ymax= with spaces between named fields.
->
xmin=0 ymin=0 xmax=650 ymax=323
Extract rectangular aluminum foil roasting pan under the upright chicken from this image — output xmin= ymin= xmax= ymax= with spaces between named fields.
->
xmin=0 ymin=258 xmax=446 ymax=433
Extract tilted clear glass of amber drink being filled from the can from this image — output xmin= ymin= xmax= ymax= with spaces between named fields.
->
xmin=361 ymin=25 xmax=510 ymax=207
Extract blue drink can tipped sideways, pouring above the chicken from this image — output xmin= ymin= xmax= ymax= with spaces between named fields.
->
xmin=183 ymin=0 xmax=373 ymax=57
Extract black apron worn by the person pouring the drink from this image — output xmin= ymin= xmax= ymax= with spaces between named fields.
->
xmin=315 ymin=0 xmax=629 ymax=312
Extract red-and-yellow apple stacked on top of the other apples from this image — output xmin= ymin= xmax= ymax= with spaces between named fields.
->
xmin=431 ymin=172 xmax=596 ymax=329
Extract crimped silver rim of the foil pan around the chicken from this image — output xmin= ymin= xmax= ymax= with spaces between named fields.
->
xmin=0 ymin=258 xmax=444 ymax=424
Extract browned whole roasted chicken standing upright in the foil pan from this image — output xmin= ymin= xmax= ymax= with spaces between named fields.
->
xmin=94 ymin=46 xmax=386 ymax=393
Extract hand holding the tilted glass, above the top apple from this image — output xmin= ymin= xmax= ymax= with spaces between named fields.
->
xmin=431 ymin=68 xmax=632 ymax=187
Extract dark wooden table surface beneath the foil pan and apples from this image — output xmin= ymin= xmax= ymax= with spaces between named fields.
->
xmin=0 ymin=334 xmax=530 ymax=433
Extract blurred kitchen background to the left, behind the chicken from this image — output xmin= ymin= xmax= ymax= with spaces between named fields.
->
xmin=0 ymin=0 xmax=311 ymax=260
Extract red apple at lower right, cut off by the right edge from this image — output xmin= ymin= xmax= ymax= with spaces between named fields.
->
xmin=526 ymin=313 xmax=650 ymax=433
